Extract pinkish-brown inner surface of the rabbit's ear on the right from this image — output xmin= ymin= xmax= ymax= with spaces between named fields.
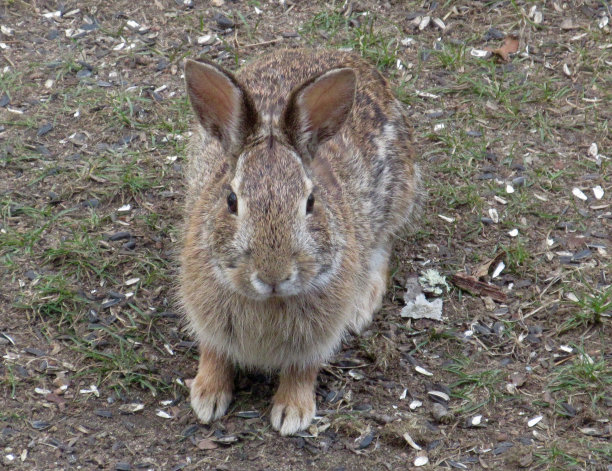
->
xmin=300 ymin=69 xmax=355 ymax=134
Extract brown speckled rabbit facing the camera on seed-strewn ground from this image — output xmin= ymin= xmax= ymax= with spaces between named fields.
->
xmin=179 ymin=49 xmax=420 ymax=435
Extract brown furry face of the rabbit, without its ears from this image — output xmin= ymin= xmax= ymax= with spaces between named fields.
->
xmin=210 ymin=138 xmax=339 ymax=299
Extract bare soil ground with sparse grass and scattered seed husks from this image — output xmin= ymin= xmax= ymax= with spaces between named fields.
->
xmin=0 ymin=0 xmax=612 ymax=470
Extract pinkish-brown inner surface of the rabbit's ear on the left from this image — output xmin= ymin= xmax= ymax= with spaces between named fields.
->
xmin=187 ymin=63 xmax=239 ymax=129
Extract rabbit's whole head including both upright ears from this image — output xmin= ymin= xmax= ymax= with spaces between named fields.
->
xmin=185 ymin=61 xmax=355 ymax=300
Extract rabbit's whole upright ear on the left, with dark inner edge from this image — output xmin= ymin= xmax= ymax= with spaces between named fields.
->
xmin=185 ymin=60 xmax=258 ymax=154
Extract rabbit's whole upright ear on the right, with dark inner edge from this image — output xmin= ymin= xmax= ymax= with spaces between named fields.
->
xmin=281 ymin=68 xmax=356 ymax=158
